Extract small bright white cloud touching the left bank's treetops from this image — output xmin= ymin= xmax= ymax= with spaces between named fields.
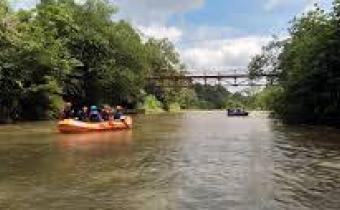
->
xmin=137 ymin=25 xmax=183 ymax=43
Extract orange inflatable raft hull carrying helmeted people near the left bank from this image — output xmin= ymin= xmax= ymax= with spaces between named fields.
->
xmin=58 ymin=117 xmax=132 ymax=133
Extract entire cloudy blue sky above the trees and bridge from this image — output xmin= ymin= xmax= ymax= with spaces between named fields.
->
xmin=13 ymin=0 xmax=332 ymax=71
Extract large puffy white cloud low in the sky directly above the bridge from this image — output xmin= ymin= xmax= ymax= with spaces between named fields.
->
xmin=181 ymin=36 xmax=271 ymax=69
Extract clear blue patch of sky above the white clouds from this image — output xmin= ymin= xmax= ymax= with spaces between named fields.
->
xmin=181 ymin=0 xmax=304 ymax=33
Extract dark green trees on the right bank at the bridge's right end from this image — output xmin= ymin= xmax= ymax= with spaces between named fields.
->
xmin=249 ymin=0 xmax=340 ymax=123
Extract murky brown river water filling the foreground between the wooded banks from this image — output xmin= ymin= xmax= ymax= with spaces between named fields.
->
xmin=0 ymin=112 xmax=340 ymax=210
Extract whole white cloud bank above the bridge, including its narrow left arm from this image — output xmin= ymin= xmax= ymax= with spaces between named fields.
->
xmin=138 ymin=25 xmax=272 ymax=70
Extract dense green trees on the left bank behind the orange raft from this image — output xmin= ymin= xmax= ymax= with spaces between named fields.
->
xmin=0 ymin=0 xmax=194 ymax=121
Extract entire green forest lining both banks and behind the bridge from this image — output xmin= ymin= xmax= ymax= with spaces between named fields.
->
xmin=0 ymin=0 xmax=340 ymax=123
